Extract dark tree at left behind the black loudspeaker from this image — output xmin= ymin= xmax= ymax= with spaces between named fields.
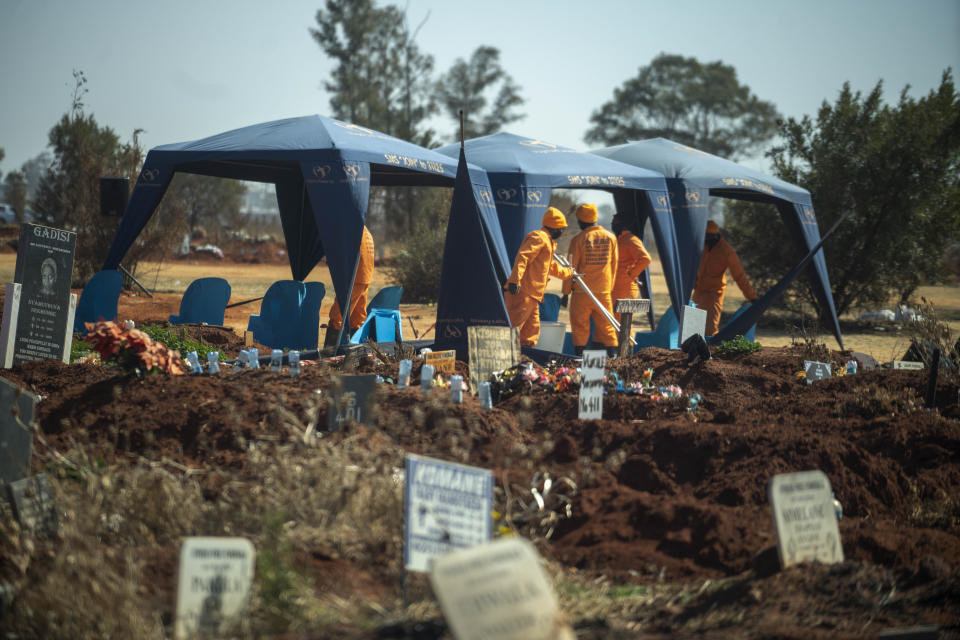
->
xmin=34 ymin=71 xmax=183 ymax=286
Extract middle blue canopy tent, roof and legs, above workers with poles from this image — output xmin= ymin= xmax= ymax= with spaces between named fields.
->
xmin=437 ymin=133 xmax=683 ymax=312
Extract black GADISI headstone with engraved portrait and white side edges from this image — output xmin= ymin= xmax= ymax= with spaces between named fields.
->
xmin=0 ymin=224 xmax=77 ymax=367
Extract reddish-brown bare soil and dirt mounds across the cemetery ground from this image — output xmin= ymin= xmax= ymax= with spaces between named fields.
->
xmin=0 ymin=251 xmax=960 ymax=639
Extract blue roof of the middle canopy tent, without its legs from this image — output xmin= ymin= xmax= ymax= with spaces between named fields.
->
xmin=436 ymin=132 xmax=665 ymax=190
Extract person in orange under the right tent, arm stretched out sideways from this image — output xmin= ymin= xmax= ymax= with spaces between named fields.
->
xmin=692 ymin=220 xmax=757 ymax=337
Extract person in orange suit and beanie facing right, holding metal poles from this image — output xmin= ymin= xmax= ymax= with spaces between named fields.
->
xmin=504 ymin=207 xmax=573 ymax=347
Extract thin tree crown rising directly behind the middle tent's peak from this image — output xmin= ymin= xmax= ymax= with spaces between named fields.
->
xmin=436 ymin=46 xmax=525 ymax=141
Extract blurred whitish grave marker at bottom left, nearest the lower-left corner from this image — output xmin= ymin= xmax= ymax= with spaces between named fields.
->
xmin=174 ymin=538 xmax=255 ymax=640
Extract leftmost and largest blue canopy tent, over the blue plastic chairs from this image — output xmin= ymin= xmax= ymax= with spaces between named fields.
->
xmin=103 ymin=115 xmax=510 ymax=344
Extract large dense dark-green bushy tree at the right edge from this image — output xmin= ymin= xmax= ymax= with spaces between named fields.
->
xmin=727 ymin=69 xmax=960 ymax=318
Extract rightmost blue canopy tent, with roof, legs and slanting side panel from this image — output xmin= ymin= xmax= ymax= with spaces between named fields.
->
xmin=591 ymin=138 xmax=843 ymax=349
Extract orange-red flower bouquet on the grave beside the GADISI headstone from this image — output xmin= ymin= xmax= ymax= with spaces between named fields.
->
xmin=84 ymin=320 xmax=186 ymax=378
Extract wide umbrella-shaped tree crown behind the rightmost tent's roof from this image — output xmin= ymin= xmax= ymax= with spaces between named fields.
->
xmin=584 ymin=53 xmax=779 ymax=160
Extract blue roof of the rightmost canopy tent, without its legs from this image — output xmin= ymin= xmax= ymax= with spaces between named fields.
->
xmin=591 ymin=138 xmax=811 ymax=205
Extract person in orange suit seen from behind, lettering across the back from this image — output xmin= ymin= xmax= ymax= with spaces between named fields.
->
xmin=560 ymin=203 xmax=619 ymax=357
